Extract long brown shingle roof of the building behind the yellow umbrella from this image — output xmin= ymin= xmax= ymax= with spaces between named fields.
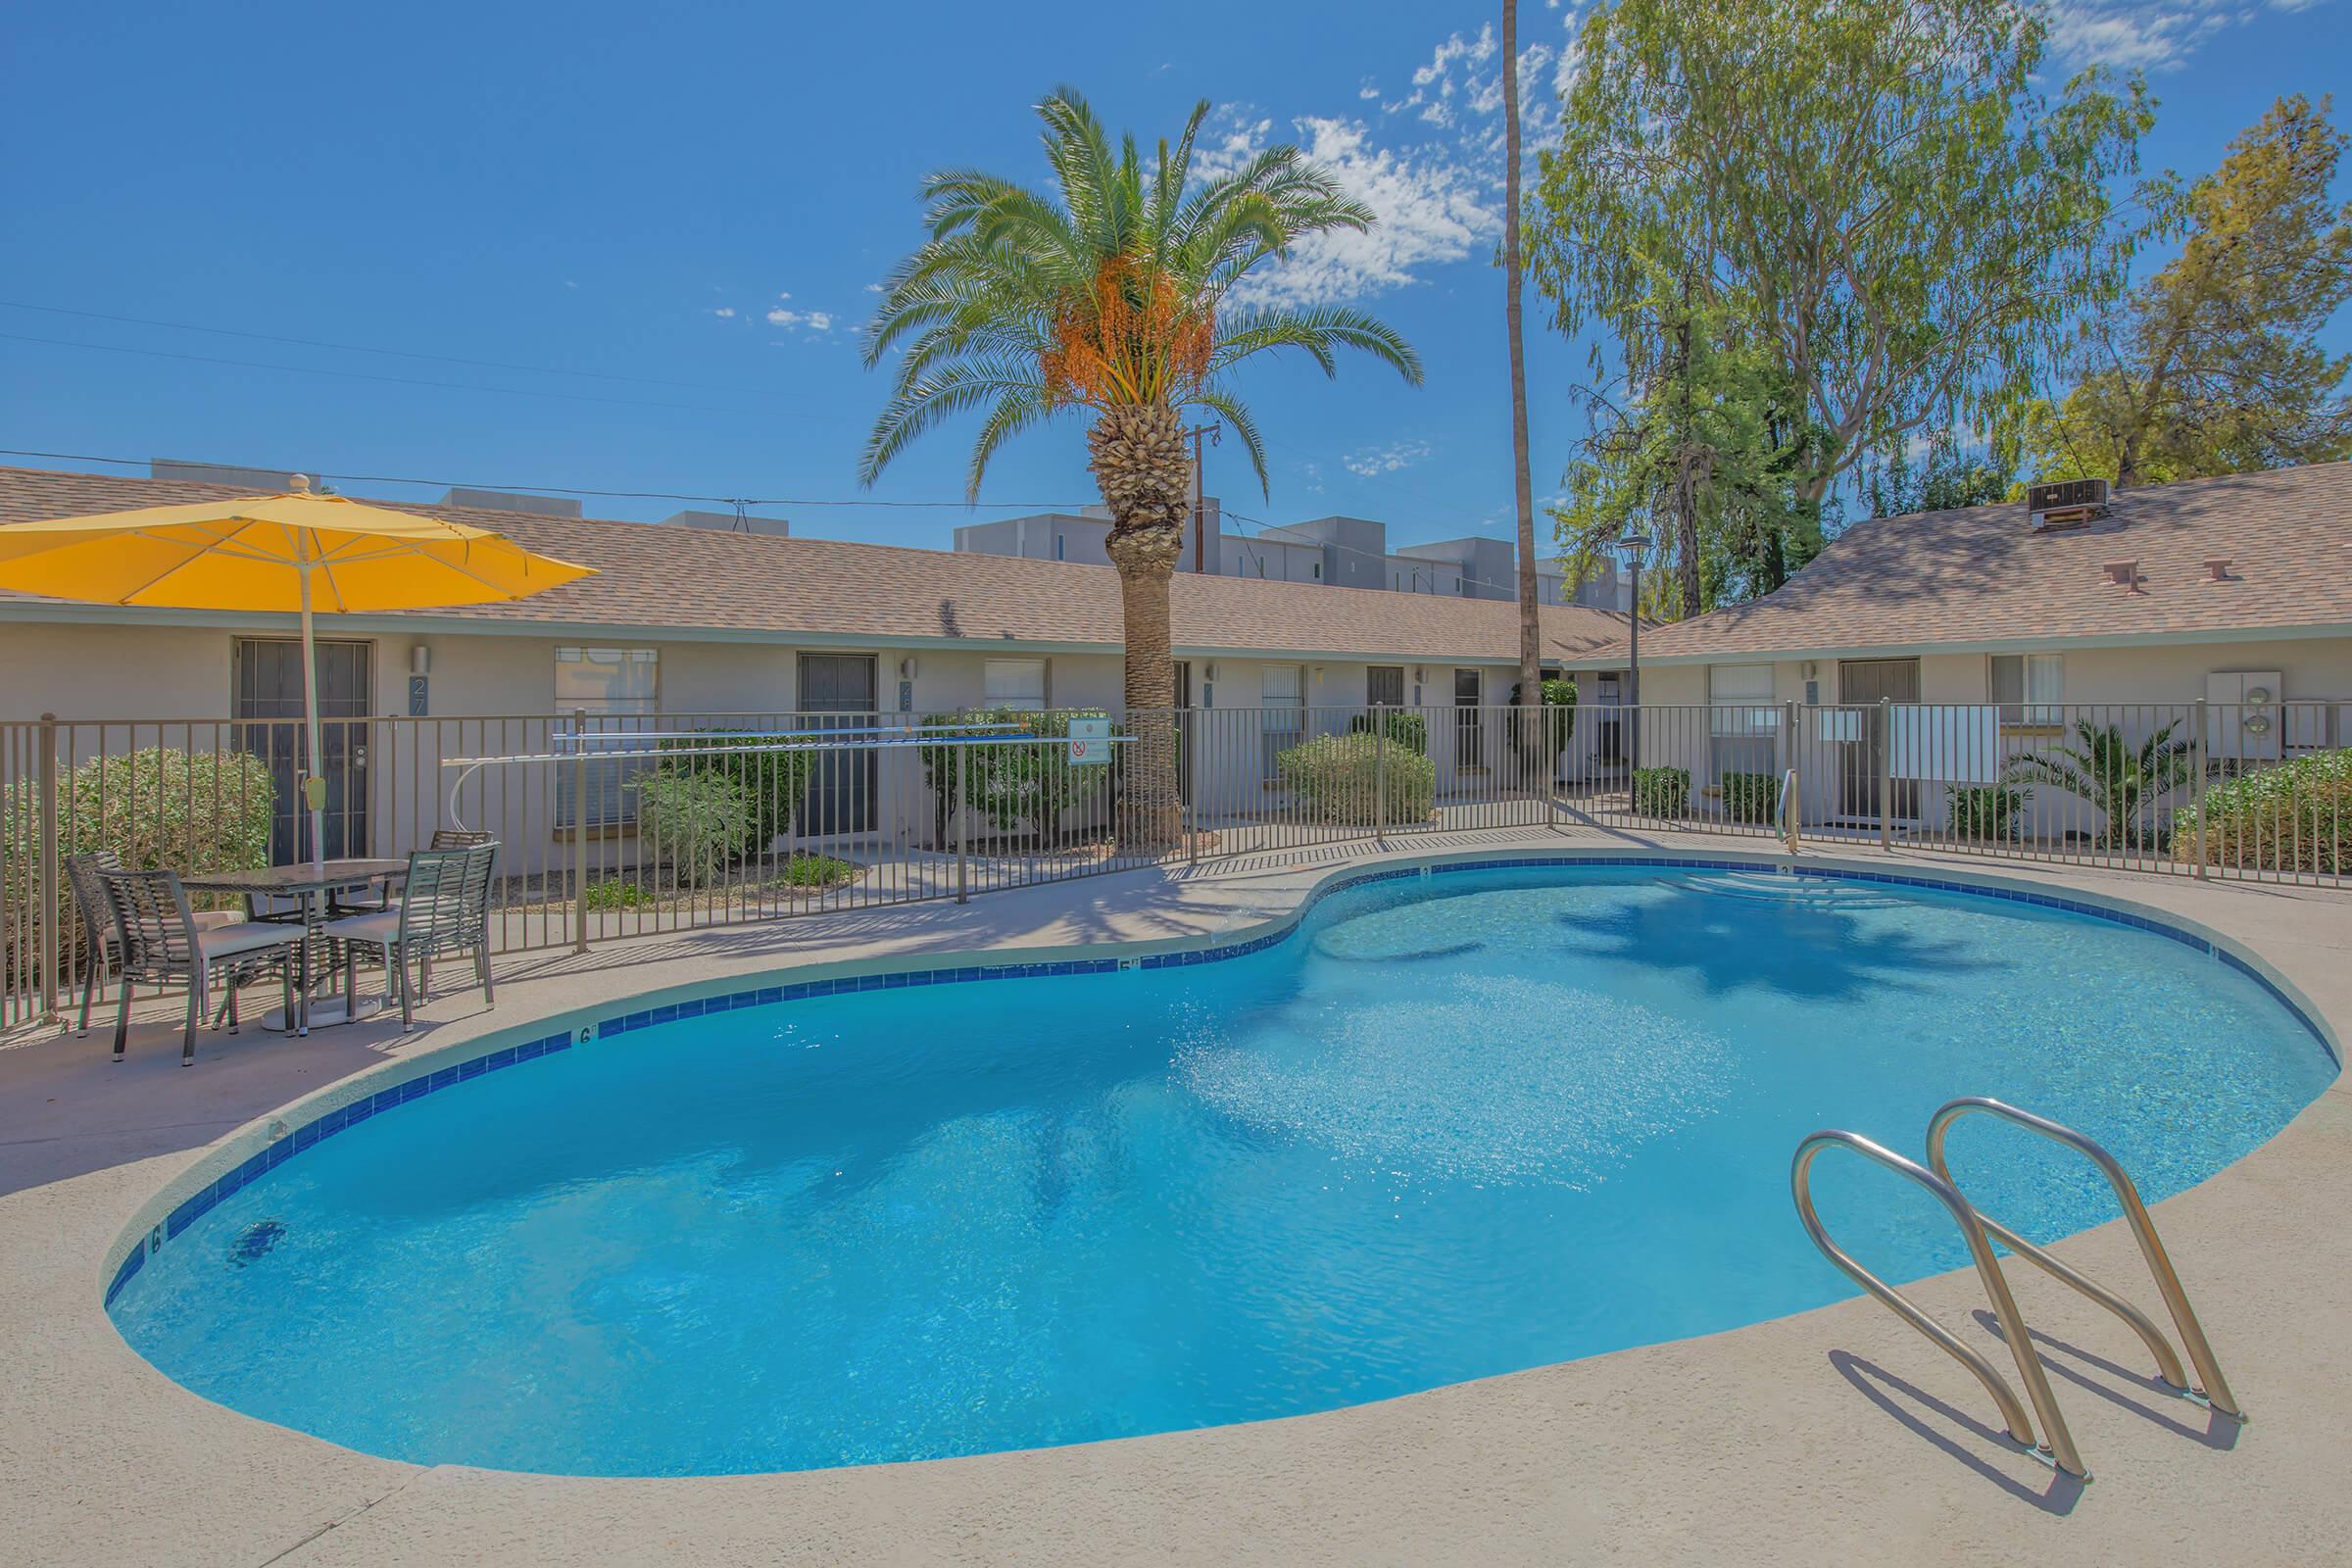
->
xmin=0 ymin=467 xmax=1625 ymax=661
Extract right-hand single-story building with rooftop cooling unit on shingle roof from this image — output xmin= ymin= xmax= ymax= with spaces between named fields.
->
xmin=1588 ymin=464 xmax=2352 ymax=827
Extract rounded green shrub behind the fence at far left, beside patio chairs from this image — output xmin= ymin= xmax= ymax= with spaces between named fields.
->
xmin=0 ymin=745 xmax=277 ymax=973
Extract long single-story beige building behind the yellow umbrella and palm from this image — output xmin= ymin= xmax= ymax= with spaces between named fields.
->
xmin=0 ymin=467 xmax=1625 ymax=858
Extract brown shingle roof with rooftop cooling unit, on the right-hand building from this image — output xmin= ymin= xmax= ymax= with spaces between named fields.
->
xmin=1580 ymin=464 xmax=2352 ymax=662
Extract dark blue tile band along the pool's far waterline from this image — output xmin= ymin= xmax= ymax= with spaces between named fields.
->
xmin=106 ymin=856 xmax=2342 ymax=1307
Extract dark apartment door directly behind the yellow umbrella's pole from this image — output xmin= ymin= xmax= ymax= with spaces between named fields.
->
xmin=233 ymin=637 xmax=376 ymax=865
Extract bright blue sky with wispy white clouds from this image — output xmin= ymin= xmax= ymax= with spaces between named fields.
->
xmin=0 ymin=0 xmax=2352 ymax=548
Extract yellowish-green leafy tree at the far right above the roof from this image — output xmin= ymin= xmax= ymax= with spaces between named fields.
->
xmin=2028 ymin=94 xmax=2352 ymax=489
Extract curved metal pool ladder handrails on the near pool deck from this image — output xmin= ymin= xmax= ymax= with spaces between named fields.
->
xmin=1789 ymin=1096 xmax=2246 ymax=1481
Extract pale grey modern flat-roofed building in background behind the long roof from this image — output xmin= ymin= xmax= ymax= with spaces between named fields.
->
xmin=955 ymin=496 xmax=1630 ymax=609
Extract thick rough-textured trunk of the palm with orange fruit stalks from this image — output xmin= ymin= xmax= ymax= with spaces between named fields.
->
xmin=1087 ymin=405 xmax=1193 ymax=854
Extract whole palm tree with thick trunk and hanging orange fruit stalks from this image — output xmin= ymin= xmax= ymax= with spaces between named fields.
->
xmin=860 ymin=87 xmax=1421 ymax=849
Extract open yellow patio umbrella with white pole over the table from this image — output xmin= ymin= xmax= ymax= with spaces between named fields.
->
xmin=0 ymin=475 xmax=595 ymax=862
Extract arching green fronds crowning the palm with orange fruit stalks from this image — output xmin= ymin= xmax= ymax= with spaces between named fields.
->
xmin=858 ymin=87 xmax=1421 ymax=494
